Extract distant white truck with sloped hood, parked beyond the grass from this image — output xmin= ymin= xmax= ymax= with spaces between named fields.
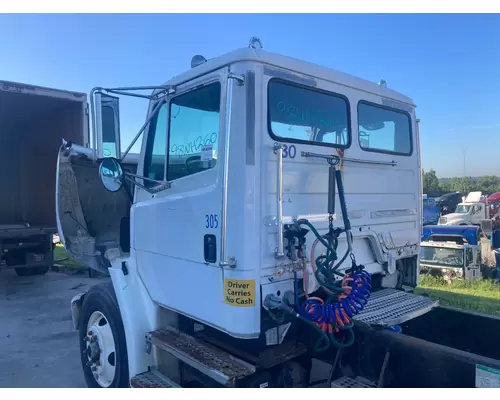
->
xmin=438 ymin=192 xmax=488 ymax=226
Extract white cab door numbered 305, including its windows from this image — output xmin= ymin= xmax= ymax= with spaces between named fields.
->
xmin=131 ymin=69 xmax=228 ymax=323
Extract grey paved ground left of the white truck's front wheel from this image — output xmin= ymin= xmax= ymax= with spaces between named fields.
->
xmin=0 ymin=270 xmax=105 ymax=388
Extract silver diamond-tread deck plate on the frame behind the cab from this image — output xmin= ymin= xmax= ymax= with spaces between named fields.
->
xmin=353 ymin=289 xmax=439 ymax=326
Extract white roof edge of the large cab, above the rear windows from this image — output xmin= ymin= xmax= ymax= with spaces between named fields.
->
xmin=158 ymin=47 xmax=415 ymax=107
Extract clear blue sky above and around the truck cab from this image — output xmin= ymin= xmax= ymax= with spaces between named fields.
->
xmin=0 ymin=14 xmax=500 ymax=177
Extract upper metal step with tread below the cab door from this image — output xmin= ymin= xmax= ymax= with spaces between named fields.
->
xmin=146 ymin=327 xmax=255 ymax=387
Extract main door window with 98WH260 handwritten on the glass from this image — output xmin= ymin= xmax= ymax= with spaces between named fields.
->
xmin=167 ymin=82 xmax=221 ymax=181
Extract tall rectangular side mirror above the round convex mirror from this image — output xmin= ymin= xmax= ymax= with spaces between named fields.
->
xmin=95 ymin=92 xmax=121 ymax=158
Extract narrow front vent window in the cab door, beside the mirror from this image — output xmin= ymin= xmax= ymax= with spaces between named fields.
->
xmin=144 ymin=104 xmax=167 ymax=187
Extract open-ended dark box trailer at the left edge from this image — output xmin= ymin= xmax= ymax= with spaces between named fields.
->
xmin=0 ymin=81 xmax=89 ymax=276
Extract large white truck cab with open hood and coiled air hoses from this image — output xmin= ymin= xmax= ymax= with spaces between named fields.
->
xmin=53 ymin=39 xmax=437 ymax=387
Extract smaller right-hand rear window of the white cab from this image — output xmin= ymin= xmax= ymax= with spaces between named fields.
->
xmin=358 ymin=102 xmax=413 ymax=156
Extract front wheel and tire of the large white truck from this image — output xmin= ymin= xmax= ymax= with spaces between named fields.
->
xmin=78 ymin=283 xmax=130 ymax=388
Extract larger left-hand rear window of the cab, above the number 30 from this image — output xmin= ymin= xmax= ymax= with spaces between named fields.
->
xmin=267 ymin=79 xmax=351 ymax=148
